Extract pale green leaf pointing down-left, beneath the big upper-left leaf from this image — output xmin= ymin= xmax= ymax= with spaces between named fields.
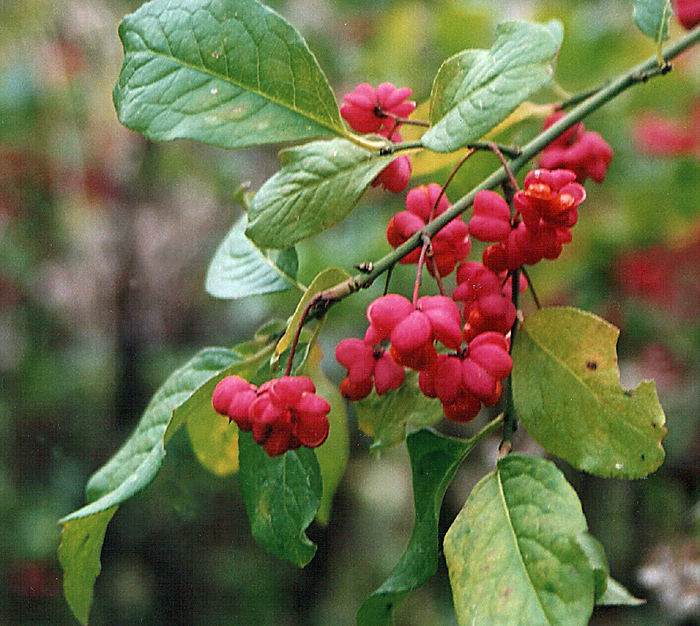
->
xmin=246 ymin=139 xmax=396 ymax=248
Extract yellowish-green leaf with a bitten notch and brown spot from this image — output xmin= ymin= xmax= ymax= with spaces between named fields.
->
xmin=512 ymin=307 xmax=666 ymax=478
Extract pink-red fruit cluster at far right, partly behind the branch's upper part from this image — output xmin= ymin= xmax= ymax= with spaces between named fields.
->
xmin=540 ymin=111 xmax=612 ymax=183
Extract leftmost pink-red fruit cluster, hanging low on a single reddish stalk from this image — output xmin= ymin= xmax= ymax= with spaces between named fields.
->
xmin=212 ymin=376 xmax=331 ymax=457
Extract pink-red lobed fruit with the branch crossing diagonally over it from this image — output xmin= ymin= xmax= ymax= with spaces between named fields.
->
xmin=386 ymin=183 xmax=471 ymax=276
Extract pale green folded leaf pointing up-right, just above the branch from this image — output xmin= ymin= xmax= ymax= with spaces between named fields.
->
xmin=421 ymin=21 xmax=563 ymax=152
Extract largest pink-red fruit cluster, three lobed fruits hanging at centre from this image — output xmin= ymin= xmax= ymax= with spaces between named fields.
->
xmin=336 ymin=294 xmax=515 ymax=422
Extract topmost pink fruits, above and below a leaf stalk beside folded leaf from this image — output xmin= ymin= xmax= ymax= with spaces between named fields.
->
xmin=340 ymin=83 xmax=416 ymax=193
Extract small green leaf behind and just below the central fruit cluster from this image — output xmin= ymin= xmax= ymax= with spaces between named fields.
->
xmin=353 ymin=371 xmax=445 ymax=450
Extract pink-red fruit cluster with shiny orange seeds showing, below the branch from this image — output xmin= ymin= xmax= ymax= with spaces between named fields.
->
xmin=469 ymin=168 xmax=586 ymax=273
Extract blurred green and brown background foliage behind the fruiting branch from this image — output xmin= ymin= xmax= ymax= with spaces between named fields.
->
xmin=0 ymin=0 xmax=700 ymax=625
